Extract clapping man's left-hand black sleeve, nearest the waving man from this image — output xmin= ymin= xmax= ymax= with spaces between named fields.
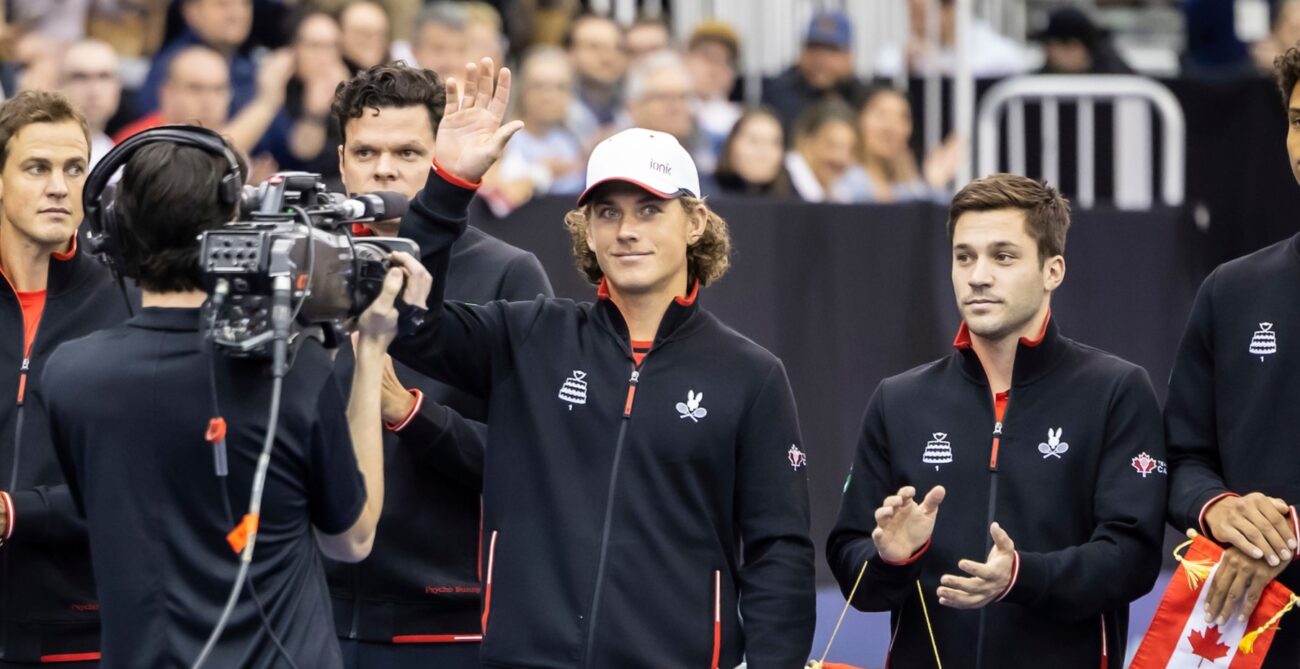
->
xmin=826 ymin=383 xmax=943 ymax=611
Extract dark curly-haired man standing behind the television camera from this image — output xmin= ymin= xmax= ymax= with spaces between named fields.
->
xmin=329 ymin=65 xmax=551 ymax=669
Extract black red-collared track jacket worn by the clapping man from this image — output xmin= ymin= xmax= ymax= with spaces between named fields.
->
xmin=827 ymin=321 xmax=1167 ymax=669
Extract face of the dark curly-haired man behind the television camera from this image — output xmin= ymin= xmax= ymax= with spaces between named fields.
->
xmin=338 ymin=105 xmax=433 ymax=235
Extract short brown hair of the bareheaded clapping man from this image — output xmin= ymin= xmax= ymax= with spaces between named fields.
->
xmin=948 ymin=174 xmax=1070 ymax=265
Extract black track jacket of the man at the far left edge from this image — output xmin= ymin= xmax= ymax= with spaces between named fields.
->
xmin=0 ymin=249 xmax=127 ymax=663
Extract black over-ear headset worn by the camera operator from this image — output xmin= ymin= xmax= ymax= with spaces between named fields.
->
xmin=82 ymin=125 xmax=243 ymax=277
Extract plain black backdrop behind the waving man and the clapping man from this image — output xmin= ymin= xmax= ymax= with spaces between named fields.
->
xmin=471 ymin=197 xmax=1206 ymax=581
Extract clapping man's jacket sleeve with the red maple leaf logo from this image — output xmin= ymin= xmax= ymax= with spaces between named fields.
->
xmin=1004 ymin=368 xmax=1167 ymax=620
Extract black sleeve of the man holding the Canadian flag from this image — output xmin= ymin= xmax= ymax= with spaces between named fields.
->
xmin=1165 ymin=274 xmax=1232 ymax=530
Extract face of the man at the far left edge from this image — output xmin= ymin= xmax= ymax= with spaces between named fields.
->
xmin=0 ymin=121 xmax=90 ymax=252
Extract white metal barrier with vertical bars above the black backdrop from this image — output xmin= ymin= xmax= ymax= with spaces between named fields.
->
xmin=975 ymin=75 xmax=1187 ymax=209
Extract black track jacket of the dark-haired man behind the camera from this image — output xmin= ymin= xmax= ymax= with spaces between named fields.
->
xmin=325 ymin=227 xmax=551 ymax=643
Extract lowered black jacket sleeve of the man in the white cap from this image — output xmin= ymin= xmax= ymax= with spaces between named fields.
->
xmin=736 ymin=362 xmax=816 ymax=669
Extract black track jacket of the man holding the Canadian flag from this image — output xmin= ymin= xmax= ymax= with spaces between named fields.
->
xmin=1165 ymin=235 xmax=1300 ymax=669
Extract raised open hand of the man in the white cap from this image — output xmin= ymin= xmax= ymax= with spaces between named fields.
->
xmin=433 ymin=58 xmax=524 ymax=182
